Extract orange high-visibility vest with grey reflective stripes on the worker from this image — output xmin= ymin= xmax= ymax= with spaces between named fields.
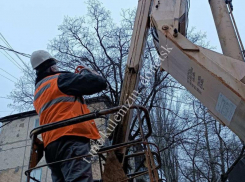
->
xmin=34 ymin=74 xmax=100 ymax=147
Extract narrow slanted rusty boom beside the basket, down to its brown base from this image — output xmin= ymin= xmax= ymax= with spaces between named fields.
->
xmin=103 ymin=0 xmax=152 ymax=182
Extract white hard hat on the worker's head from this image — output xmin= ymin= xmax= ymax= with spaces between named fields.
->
xmin=31 ymin=50 xmax=57 ymax=69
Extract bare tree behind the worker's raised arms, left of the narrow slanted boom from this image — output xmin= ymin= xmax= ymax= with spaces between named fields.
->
xmin=48 ymin=0 xmax=134 ymax=106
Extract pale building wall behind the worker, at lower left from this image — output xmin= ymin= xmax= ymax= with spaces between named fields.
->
xmin=0 ymin=104 xmax=105 ymax=182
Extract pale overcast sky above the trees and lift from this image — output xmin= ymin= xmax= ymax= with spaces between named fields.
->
xmin=0 ymin=0 xmax=245 ymax=117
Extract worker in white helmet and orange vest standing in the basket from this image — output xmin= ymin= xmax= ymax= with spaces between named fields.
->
xmin=31 ymin=50 xmax=107 ymax=182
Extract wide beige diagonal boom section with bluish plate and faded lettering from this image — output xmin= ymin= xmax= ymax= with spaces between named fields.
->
xmin=158 ymin=27 xmax=245 ymax=141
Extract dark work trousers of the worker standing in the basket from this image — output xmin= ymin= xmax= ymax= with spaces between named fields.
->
xmin=45 ymin=136 xmax=93 ymax=182
